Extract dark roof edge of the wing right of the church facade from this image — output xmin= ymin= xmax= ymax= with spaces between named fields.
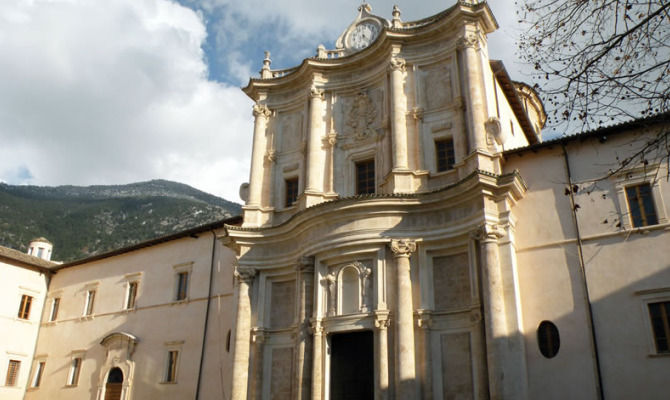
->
xmin=503 ymin=111 xmax=670 ymax=156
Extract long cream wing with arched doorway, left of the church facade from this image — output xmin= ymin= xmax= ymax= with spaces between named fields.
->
xmin=25 ymin=218 xmax=239 ymax=400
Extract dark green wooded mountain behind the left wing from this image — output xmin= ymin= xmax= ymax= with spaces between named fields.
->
xmin=0 ymin=180 xmax=241 ymax=262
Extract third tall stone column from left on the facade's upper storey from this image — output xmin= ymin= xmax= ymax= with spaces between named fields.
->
xmin=390 ymin=57 xmax=408 ymax=171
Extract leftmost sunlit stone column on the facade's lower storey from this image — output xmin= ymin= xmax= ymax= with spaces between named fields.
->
xmin=231 ymin=267 xmax=256 ymax=400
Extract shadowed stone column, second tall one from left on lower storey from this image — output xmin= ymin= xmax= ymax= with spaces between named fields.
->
xmin=294 ymin=257 xmax=314 ymax=400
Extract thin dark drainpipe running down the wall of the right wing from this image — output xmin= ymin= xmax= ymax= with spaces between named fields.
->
xmin=561 ymin=143 xmax=605 ymax=400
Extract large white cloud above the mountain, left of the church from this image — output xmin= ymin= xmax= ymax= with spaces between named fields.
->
xmin=0 ymin=0 xmax=252 ymax=201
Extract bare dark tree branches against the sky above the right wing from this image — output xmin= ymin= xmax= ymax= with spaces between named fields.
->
xmin=517 ymin=0 xmax=670 ymax=173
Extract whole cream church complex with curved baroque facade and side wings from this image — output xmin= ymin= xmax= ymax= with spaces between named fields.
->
xmin=0 ymin=1 xmax=670 ymax=400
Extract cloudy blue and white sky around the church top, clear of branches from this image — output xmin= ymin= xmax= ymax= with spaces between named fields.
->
xmin=0 ymin=0 xmax=528 ymax=202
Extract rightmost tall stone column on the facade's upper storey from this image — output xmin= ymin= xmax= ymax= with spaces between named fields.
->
xmin=459 ymin=33 xmax=487 ymax=152
